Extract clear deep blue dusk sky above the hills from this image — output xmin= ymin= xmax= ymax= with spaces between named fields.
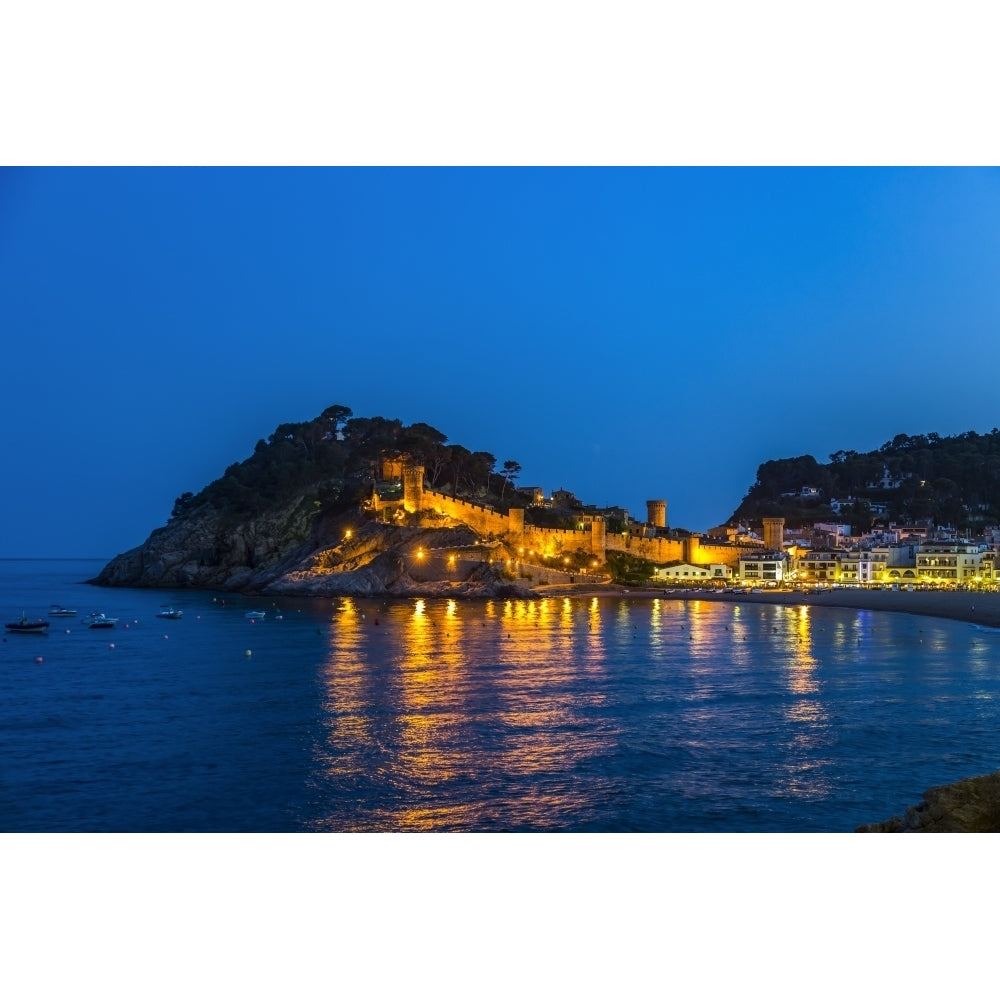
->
xmin=0 ymin=167 xmax=1000 ymax=557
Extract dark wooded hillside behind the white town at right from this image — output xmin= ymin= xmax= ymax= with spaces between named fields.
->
xmin=733 ymin=428 xmax=1000 ymax=533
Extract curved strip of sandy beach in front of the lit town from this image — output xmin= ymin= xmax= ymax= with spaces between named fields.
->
xmin=535 ymin=585 xmax=1000 ymax=628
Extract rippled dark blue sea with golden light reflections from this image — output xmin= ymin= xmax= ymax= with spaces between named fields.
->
xmin=0 ymin=560 xmax=1000 ymax=832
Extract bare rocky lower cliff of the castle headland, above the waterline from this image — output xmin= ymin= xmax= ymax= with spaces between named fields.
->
xmin=91 ymin=499 xmax=530 ymax=597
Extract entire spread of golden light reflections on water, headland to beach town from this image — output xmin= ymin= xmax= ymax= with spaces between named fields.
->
xmin=319 ymin=597 xmax=876 ymax=830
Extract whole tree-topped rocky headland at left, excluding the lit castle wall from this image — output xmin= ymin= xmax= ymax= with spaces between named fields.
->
xmin=91 ymin=405 xmax=592 ymax=596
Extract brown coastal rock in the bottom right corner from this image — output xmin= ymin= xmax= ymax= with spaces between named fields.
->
xmin=855 ymin=771 xmax=1000 ymax=833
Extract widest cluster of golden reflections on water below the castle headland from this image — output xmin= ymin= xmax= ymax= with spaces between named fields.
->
xmin=323 ymin=599 xmax=614 ymax=830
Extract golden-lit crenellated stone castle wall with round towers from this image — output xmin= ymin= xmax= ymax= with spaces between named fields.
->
xmin=371 ymin=464 xmax=764 ymax=570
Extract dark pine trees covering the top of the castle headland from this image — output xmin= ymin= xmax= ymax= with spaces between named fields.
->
xmin=172 ymin=405 xmax=524 ymax=517
